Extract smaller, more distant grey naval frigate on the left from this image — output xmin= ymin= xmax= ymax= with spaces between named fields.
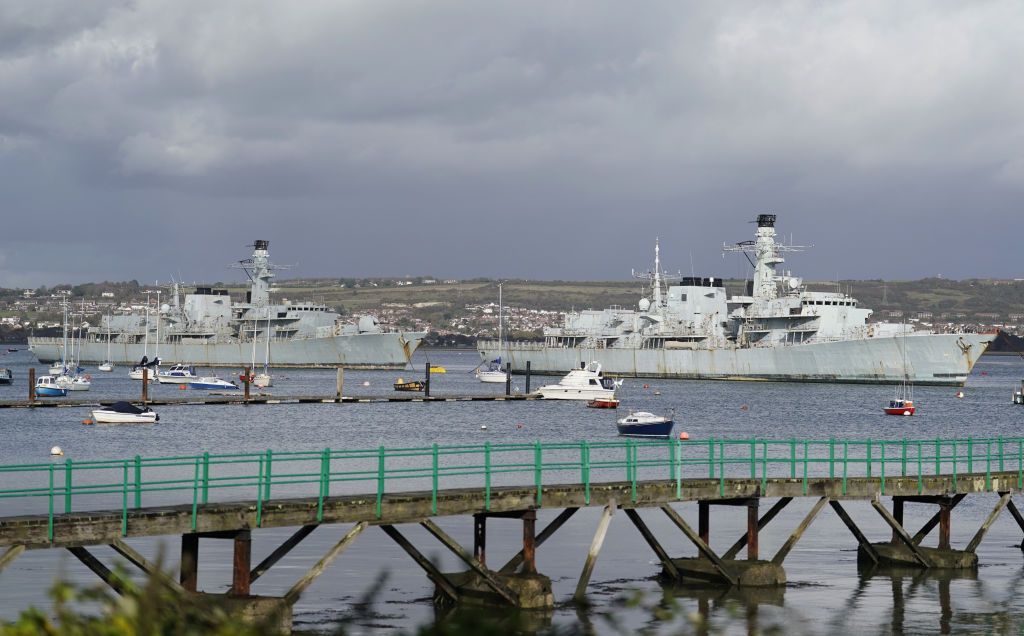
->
xmin=29 ymin=241 xmax=426 ymax=369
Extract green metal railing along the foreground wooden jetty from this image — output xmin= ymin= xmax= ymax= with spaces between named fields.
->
xmin=0 ymin=437 xmax=1024 ymax=541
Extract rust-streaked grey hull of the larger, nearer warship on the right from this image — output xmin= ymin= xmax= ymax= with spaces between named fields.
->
xmin=477 ymin=334 xmax=995 ymax=386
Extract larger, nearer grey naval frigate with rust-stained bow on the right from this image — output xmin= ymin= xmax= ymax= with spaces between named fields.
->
xmin=477 ymin=214 xmax=995 ymax=386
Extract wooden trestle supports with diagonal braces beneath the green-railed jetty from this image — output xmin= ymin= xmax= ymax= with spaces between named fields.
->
xmin=6 ymin=492 xmax=1024 ymax=632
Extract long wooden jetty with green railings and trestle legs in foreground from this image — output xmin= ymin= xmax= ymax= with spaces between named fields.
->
xmin=0 ymin=437 xmax=1024 ymax=630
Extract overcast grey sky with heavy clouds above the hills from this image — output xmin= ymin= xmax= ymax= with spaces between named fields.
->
xmin=0 ymin=0 xmax=1024 ymax=287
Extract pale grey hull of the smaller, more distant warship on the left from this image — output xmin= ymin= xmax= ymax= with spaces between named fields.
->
xmin=29 ymin=332 xmax=426 ymax=369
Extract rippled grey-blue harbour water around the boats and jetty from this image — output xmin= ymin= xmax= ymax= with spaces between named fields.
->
xmin=0 ymin=351 xmax=1024 ymax=634
